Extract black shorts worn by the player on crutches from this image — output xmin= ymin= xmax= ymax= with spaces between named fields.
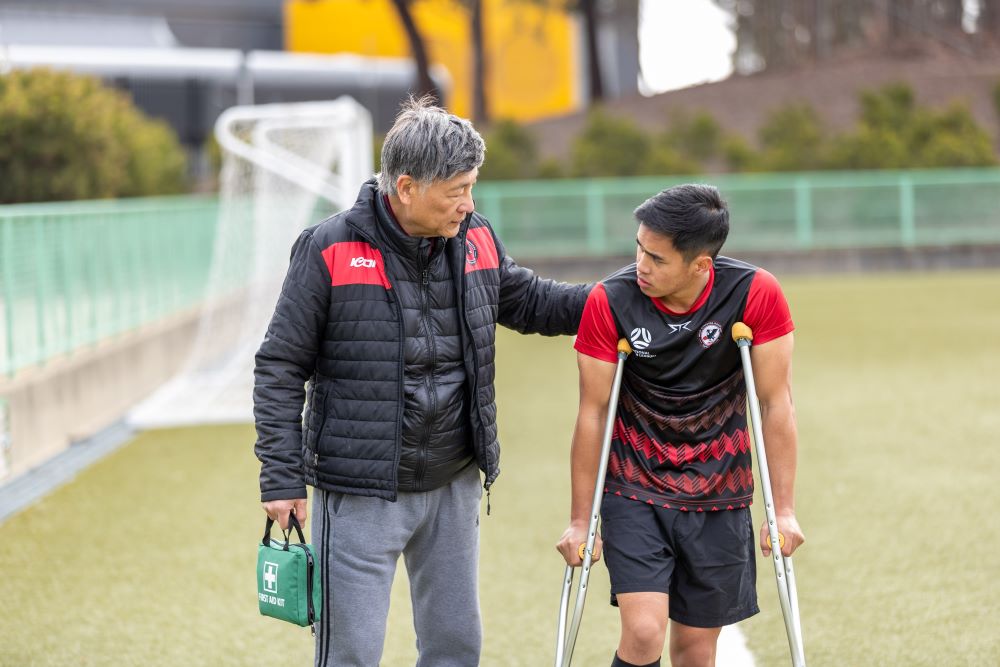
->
xmin=601 ymin=493 xmax=759 ymax=628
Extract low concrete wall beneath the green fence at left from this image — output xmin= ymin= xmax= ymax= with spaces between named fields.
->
xmin=0 ymin=309 xmax=199 ymax=480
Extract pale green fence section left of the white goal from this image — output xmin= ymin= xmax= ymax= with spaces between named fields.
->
xmin=0 ymin=197 xmax=218 ymax=375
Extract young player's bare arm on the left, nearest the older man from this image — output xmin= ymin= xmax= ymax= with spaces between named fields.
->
xmin=556 ymin=352 xmax=616 ymax=566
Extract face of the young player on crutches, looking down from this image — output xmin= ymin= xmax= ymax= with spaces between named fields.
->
xmin=635 ymin=224 xmax=712 ymax=299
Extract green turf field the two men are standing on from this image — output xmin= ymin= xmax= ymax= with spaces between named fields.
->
xmin=0 ymin=272 xmax=1000 ymax=667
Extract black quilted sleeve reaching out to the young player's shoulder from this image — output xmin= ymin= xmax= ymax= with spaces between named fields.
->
xmin=493 ymin=234 xmax=594 ymax=336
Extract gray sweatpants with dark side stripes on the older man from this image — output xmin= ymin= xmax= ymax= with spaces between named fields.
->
xmin=312 ymin=465 xmax=482 ymax=667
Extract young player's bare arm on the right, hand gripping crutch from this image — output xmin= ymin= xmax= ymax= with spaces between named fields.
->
xmin=750 ymin=333 xmax=805 ymax=556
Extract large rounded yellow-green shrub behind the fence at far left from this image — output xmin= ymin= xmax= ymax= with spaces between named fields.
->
xmin=0 ymin=69 xmax=186 ymax=203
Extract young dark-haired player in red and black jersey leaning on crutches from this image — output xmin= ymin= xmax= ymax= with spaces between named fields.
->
xmin=557 ymin=185 xmax=804 ymax=667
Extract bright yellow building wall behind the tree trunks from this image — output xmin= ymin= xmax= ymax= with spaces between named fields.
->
xmin=285 ymin=0 xmax=579 ymax=120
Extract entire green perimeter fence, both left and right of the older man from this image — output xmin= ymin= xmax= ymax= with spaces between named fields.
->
xmin=0 ymin=169 xmax=1000 ymax=375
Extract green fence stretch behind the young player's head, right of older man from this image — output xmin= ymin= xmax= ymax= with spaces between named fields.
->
xmin=475 ymin=169 xmax=1000 ymax=259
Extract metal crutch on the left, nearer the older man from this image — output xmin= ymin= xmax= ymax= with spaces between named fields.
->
xmin=555 ymin=338 xmax=632 ymax=667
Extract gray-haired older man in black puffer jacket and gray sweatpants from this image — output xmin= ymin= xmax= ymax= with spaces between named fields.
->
xmin=254 ymin=100 xmax=589 ymax=667
